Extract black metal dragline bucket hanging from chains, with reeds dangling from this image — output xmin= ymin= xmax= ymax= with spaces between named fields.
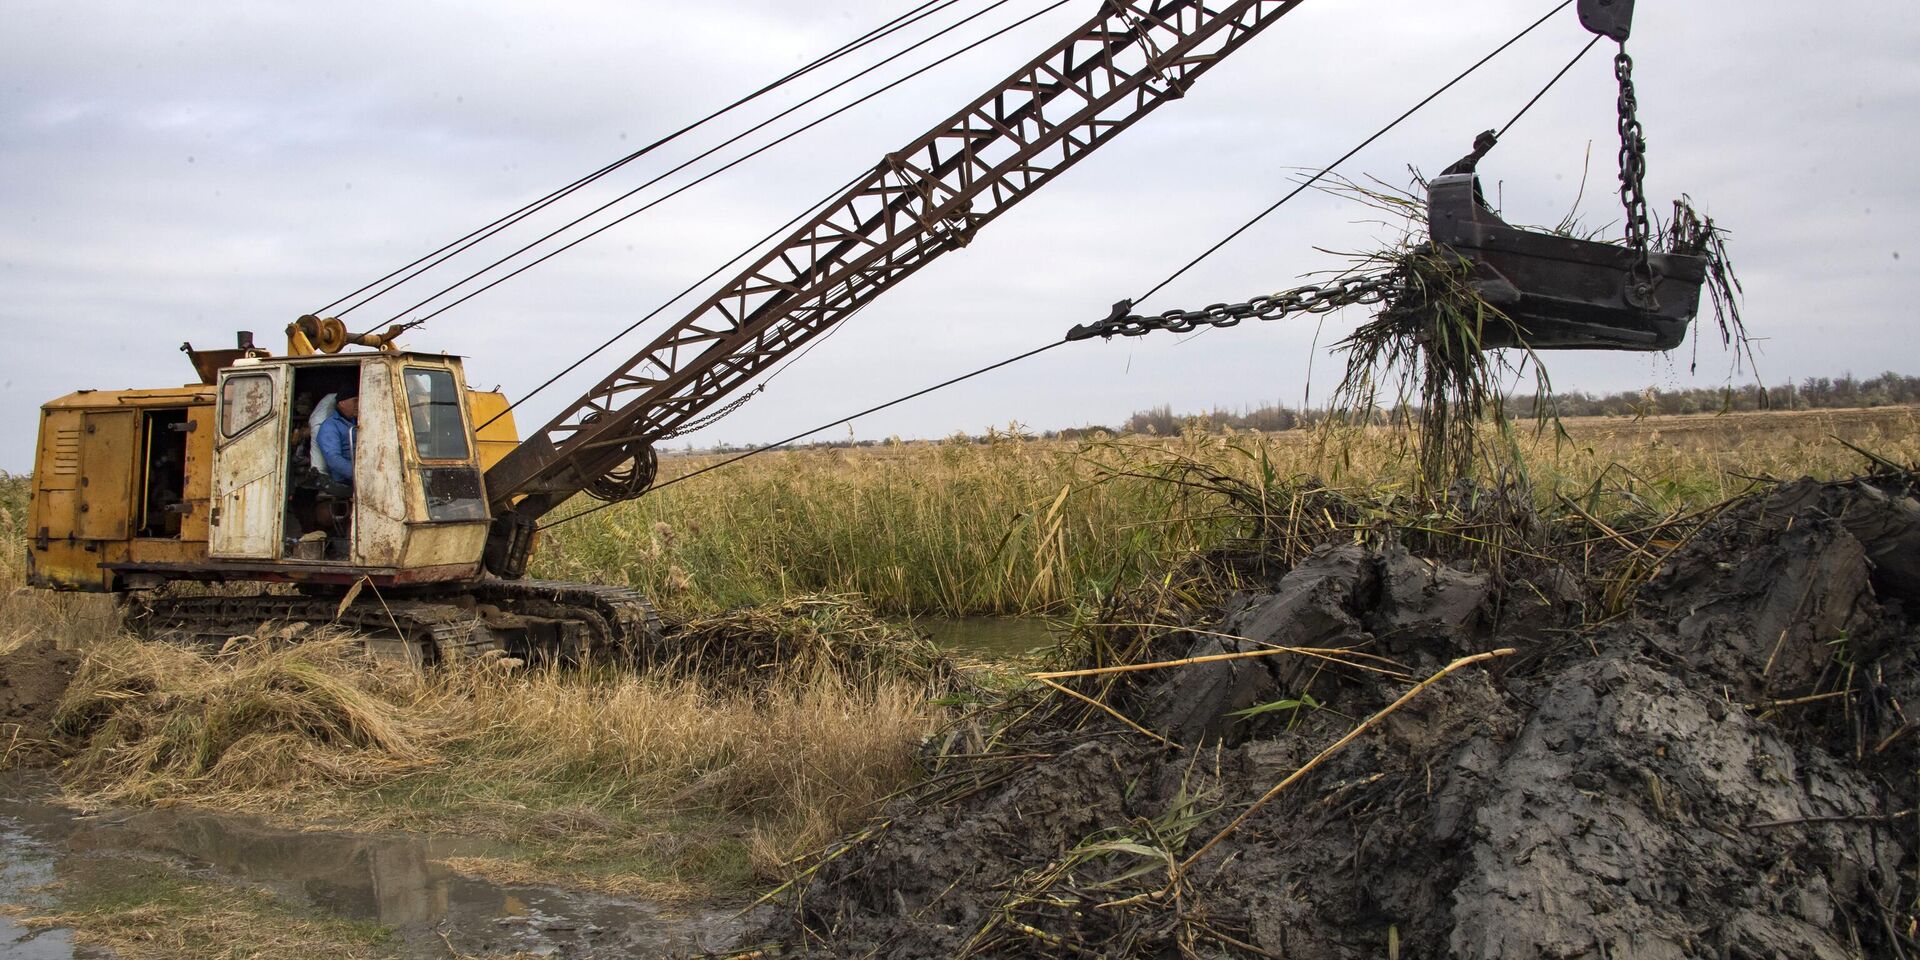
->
xmin=1427 ymin=173 xmax=1707 ymax=351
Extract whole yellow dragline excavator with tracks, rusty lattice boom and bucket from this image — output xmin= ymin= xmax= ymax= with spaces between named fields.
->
xmin=25 ymin=0 xmax=1699 ymax=662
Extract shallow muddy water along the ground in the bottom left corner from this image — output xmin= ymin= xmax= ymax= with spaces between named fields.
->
xmin=0 ymin=780 xmax=737 ymax=960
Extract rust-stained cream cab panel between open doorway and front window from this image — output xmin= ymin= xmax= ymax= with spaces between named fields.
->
xmin=353 ymin=357 xmax=413 ymax=566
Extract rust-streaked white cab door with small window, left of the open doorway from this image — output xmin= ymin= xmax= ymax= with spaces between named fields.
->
xmin=207 ymin=365 xmax=288 ymax=559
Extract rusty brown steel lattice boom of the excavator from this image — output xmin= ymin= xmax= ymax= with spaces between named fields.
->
xmin=488 ymin=0 xmax=1300 ymax=516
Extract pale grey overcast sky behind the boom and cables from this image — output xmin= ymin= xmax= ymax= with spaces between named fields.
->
xmin=0 ymin=0 xmax=1920 ymax=472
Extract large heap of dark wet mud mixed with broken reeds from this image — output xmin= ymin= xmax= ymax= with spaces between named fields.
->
xmin=768 ymin=478 xmax=1920 ymax=960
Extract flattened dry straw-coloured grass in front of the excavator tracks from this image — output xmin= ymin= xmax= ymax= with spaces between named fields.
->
xmin=41 ymin=601 xmax=935 ymax=899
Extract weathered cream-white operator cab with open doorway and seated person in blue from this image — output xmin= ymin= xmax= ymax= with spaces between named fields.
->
xmin=207 ymin=351 xmax=488 ymax=582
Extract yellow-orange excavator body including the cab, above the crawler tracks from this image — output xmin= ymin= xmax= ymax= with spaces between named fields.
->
xmin=27 ymin=359 xmax=499 ymax=591
